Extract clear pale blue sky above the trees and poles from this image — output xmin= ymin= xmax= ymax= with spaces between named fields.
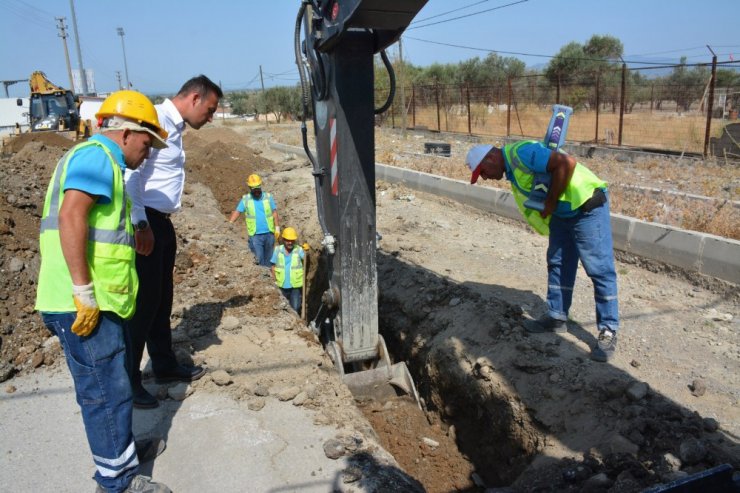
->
xmin=0 ymin=0 xmax=740 ymax=97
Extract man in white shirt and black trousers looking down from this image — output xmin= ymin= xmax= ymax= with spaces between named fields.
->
xmin=126 ymin=75 xmax=223 ymax=409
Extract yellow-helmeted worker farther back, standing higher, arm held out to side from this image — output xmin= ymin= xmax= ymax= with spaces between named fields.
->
xmin=229 ymin=174 xmax=280 ymax=267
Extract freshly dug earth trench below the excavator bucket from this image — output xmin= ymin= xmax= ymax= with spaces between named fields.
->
xmin=307 ymin=251 xmax=544 ymax=492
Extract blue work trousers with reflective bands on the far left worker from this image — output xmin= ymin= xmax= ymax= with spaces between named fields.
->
xmin=41 ymin=312 xmax=139 ymax=492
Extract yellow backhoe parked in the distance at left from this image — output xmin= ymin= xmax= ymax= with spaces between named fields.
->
xmin=18 ymin=71 xmax=91 ymax=140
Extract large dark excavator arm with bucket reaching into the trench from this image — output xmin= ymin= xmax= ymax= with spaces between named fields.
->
xmin=294 ymin=0 xmax=427 ymax=403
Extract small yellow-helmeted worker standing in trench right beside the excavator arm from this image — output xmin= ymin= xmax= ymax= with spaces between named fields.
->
xmin=270 ymin=227 xmax=306 ymax=315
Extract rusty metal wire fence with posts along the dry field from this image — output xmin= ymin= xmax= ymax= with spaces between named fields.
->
xmin=376 ymin=61 xmax=740 ymax=156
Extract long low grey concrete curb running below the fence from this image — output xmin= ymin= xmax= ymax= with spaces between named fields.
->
xmin=271 ymin=144 xmax=740 ymax=284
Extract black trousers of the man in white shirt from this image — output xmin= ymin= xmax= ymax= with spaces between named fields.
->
xmin=126 ymin=207 xmax=177 ymax=386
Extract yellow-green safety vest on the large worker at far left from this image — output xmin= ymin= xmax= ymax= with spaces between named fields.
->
xmin=36 ymin=141 xmax=139 ymax=319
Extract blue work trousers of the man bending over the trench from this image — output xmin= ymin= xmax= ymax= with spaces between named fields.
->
xmin=547 ymin=195 xmax=619 ymax=331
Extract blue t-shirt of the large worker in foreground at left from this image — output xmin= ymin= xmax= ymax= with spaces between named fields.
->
xmin=64 ymin=134 xmax=126 ymax=204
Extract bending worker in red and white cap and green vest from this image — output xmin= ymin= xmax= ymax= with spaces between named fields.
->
xmin=466 ymin=141 xmax=619 ymax=362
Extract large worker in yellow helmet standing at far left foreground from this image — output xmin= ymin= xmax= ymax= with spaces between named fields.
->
xmin=36 ymin=91 xmax=170 ymax=492
